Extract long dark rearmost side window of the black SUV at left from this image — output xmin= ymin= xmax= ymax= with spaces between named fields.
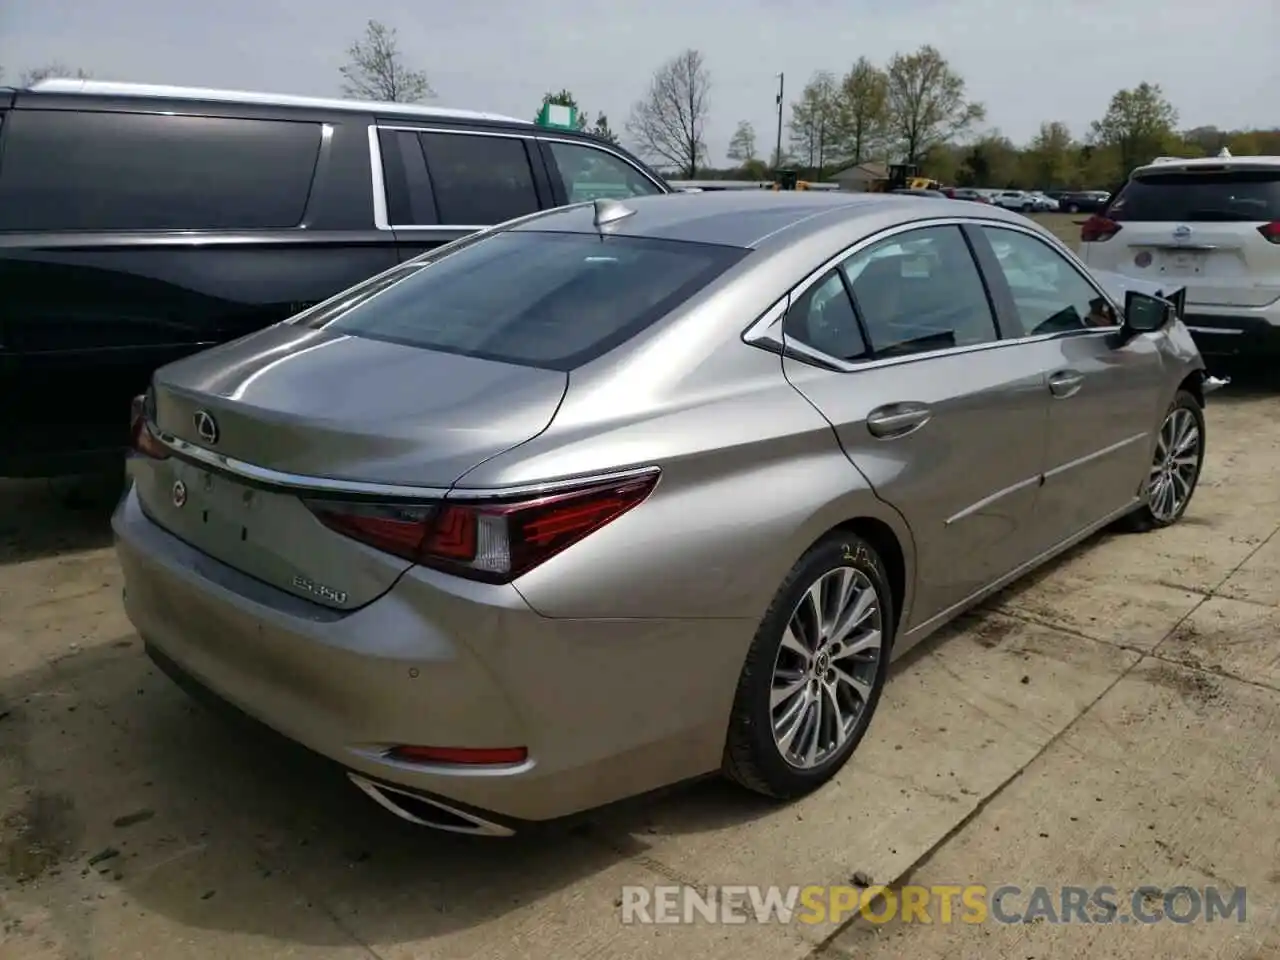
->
xmin=0 ymin=110 xmax=320 ymax=230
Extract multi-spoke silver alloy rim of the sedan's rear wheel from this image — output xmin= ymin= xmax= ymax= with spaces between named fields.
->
xmin=769 ymin=567 xmax=883 ymax=769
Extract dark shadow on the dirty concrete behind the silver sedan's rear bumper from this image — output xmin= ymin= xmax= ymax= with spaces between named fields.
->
xmin=0 ymin=635 xmax=777 ymax=946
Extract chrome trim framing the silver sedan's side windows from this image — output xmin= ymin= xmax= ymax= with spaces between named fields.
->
xmin=742 ymin=216 xmax=1120 ymax=374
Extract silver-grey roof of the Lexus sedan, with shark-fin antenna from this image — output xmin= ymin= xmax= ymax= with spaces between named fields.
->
xmin=511 ymin=191 xmax=1024 ymax=250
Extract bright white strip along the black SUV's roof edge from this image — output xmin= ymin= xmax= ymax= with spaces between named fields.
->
xmin=27 ymin=78 xmax=534 ymax=127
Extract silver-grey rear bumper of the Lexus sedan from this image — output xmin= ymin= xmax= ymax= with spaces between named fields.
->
xmin=113 ymin=489 xmax=754 ymax=822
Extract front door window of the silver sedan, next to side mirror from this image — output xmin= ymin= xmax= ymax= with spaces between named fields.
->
xmin=982 ymin=227 xmax=1116 ymax=337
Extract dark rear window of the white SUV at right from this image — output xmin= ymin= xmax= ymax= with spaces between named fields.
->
xmin=1107 ymin=169 xmax=1280 ymax=223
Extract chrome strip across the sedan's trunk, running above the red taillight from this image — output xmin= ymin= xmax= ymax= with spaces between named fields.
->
xmin=150 ymin=424 xmax=660 ymax=502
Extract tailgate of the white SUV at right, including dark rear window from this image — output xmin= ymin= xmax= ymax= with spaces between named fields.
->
xmin=1083 ymin=164 xmax=1280 ymax=307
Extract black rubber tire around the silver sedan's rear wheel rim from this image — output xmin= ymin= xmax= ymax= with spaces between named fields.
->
xmin=723 ymin=531 xmax=896 ymax=800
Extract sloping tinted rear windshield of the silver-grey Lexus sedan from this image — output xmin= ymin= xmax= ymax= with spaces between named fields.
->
xmin=308 ymin=230 xmax=748 ymax=370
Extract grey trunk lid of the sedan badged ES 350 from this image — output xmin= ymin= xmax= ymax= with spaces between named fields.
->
xmin=131 ymin=325 xmax=567 ymax=609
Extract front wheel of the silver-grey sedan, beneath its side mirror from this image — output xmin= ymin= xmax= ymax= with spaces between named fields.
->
xmin=1126 ymin=390 xmax=1204 ymax=531
